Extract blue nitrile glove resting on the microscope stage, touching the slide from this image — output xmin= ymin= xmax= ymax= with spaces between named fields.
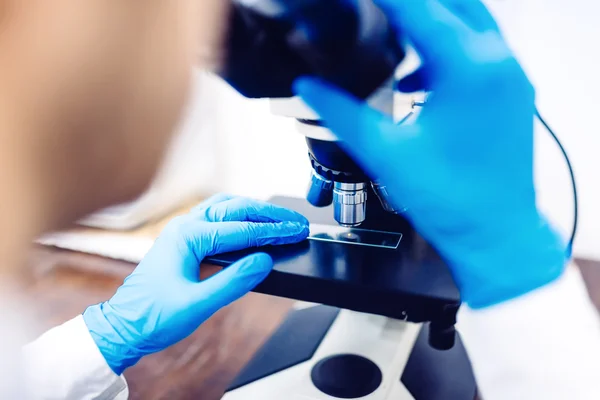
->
xmin=83 ymin=195 xmax=308 ymax=374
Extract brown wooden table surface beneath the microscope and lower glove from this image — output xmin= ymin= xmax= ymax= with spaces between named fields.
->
xmin=25 ymin=247 xmax=600 ymax=400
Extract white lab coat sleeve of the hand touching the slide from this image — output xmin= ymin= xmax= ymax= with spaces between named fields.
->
xmin=23 ymin=316 xmax=129 ymax=400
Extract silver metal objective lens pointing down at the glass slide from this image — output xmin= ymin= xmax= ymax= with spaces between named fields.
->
xmin=333 ymin=182 xmax=367 ymax=227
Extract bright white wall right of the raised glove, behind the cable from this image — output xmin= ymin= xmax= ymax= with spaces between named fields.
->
xmin=487 ymin=0 xmax=600 ymax=259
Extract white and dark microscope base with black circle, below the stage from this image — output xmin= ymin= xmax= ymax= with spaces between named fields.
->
xmin=223 ymin=306 xmax=476 ymax=400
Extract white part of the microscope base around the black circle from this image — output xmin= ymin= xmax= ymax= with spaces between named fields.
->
xmin=223 ymin=306 xmax=475 ymax=400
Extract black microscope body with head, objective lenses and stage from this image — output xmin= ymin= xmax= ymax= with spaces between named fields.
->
xmin=207 ymin=0 xmax=474 ymax=399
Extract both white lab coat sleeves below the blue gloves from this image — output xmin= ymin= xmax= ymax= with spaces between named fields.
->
xmin=0 ymin=262 xmax=600 ymax=400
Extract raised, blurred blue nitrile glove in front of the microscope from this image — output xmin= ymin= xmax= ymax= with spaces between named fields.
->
xmin=295 ymin=0 xmax=566 ymax=308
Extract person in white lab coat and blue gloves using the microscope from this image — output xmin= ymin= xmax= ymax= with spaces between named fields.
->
xmin=0 ymin=0 xmax=600 ymax=399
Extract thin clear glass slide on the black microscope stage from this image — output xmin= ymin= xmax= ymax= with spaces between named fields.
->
xmin=308 ymin=224 xmax=402 ymax=249
